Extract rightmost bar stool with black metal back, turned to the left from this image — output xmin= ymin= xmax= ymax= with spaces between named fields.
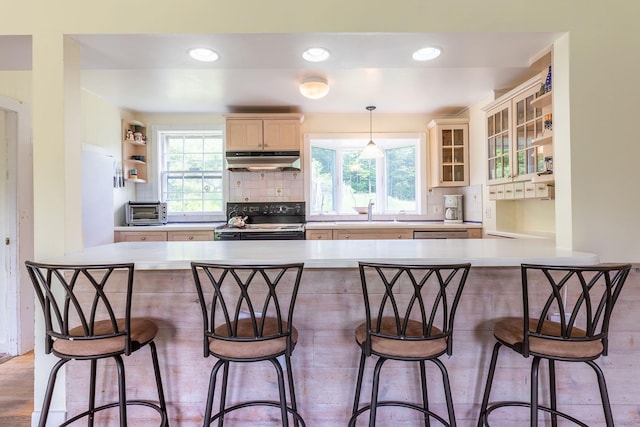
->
xmin=478 ymin=264 xmax=631 ymax=427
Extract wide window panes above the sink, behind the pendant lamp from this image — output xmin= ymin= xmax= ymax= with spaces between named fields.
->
xmin=308 ymin=134 xmax=421 ymax=215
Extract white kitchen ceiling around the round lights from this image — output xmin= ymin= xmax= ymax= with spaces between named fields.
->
xmin=0 ymin=32 xmax=561 ymax=115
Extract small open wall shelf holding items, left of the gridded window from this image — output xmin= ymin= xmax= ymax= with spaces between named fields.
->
xmin=122 ymin=119 xmax=147 ymax=182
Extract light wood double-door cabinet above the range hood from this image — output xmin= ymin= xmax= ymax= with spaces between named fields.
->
xmin=226 ymin=113 xmax=303 ymax=151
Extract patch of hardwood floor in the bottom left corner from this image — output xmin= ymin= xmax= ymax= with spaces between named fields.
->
xmin=0 ymin=351 xmax=33 ymax=427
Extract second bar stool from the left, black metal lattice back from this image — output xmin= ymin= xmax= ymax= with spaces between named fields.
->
xmin=191 ymin=262 xmax=305 ymax=427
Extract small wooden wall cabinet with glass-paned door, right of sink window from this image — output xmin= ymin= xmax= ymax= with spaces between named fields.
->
xmin=427 ymin=119 xmax=469 ymax=187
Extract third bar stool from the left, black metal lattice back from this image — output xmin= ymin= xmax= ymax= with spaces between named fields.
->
xmin=349 ymin=262 xmax=471 ymax=427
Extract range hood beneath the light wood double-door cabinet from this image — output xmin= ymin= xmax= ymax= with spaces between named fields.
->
xmin=226 ymin=151 xmax=300 ymax=171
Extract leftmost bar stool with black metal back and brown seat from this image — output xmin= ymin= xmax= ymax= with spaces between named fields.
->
xmin=26 ymin=261 xmax=169 ymax=427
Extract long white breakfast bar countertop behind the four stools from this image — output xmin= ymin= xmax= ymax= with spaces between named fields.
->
xmin=46 ymin=239 xmax=599 ymax=270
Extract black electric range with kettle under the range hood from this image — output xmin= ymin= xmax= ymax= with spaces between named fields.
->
xmin=214 ymin=202 xmax=305 ymax=240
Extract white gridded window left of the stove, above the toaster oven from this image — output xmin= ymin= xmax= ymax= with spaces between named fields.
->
xmin=158 ymin=131 xmax=224 ymax=220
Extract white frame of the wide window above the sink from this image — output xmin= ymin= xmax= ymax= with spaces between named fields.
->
xmin=304 ymin=132 xmax=427 ymax=221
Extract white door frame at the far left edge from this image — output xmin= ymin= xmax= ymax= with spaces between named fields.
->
xmin=0 ymin=96 xmax=35 ymax=355
